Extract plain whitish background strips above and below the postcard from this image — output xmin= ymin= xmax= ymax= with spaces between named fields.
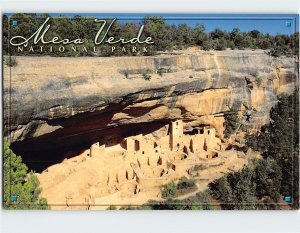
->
xmin=0 ymin=0 xmax=300 ymax=233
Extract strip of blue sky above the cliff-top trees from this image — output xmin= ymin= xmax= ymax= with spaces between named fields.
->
xmin=8 ymin=13 xmax=299 ymax=35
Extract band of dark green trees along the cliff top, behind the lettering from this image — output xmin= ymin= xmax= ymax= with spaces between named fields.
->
xmin=3 ymin=14 xmax=299 ymax=56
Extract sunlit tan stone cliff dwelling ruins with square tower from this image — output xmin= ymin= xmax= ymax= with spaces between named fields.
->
xmin=39 ymin=120 xmax=250 ymax=209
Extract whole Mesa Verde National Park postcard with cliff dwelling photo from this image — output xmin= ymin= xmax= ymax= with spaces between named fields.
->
xmin=2 ymin=13 xmax=299 ymax=210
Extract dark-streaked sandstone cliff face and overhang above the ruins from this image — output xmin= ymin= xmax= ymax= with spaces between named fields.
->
xmin=4 ymin=51 xmax=298 ymax=169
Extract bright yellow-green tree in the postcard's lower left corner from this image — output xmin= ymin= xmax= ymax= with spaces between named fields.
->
xmin=3 ymin=140 xmax=49 ymax=209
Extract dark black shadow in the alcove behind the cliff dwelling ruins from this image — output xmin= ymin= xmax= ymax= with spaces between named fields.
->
xmin=11 ymin=121 xmax=169 ymax=172
